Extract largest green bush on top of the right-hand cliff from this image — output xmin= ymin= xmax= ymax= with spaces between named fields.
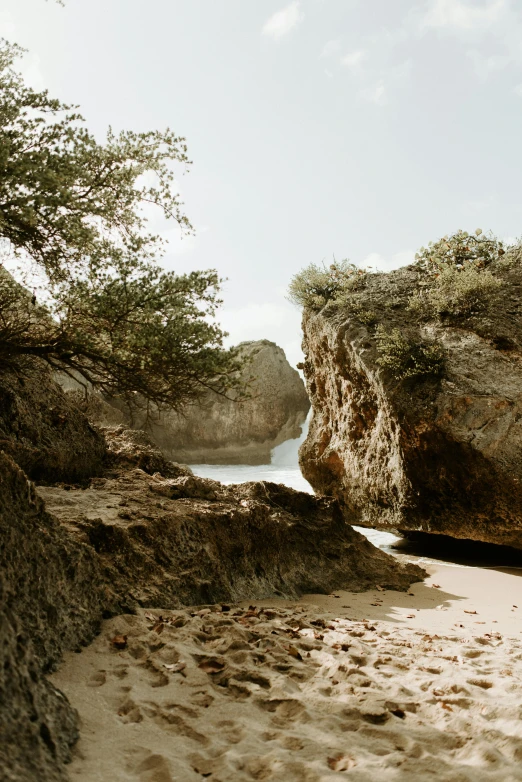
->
xmin=408 ymin=229 xmax=505 ymax=318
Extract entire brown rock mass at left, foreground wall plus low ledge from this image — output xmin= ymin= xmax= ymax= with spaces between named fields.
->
xmin=0 ymin=378 xmax=424 ymax=782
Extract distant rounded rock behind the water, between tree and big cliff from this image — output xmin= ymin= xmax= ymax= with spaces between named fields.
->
xmin=134 ymin=340 xmax=310 ymax=464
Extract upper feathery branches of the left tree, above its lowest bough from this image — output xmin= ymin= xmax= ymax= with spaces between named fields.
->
xmin=0 ymin=41 xmax=192 ymax=281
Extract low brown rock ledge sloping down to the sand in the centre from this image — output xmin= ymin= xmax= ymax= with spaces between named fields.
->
xmin=39 ymin=469 xmax=424 ymax=611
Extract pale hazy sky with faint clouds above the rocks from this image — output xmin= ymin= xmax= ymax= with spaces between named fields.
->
xmin=0 ymin=0 xmax=522 ymax=365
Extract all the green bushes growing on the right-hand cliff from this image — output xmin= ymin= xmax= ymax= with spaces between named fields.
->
xmin=289 ymin=229 xmax=522 ymax=380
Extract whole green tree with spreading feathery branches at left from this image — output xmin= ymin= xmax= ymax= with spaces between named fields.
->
xmin=0 ymin=41 xmax=240 ymax=408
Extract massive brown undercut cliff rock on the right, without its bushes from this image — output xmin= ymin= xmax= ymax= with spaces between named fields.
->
xmin=300 ymin=262 xmax=522 ymax=548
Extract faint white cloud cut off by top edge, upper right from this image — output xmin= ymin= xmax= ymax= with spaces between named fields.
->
xmin=420 ymin=0 xmax=507 ymax=30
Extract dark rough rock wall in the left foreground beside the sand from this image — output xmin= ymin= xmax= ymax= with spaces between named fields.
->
xmin=0 ymin=452 xmax=106 ymax=782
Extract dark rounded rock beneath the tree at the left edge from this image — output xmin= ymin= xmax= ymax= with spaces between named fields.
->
xmin=0 ymin=358 xmax=105 ymax=483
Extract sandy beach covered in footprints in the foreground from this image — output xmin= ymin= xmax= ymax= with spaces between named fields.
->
xmin=51 ymin=565 xmax=522 ymax=782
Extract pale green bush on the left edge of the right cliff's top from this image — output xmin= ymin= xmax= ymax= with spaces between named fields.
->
xmin=288 ymin=260 xmax=367 ymax=312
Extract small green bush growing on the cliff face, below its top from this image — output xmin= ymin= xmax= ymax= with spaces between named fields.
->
xmin=376 ymin=326 xmax=444 ymax=380
